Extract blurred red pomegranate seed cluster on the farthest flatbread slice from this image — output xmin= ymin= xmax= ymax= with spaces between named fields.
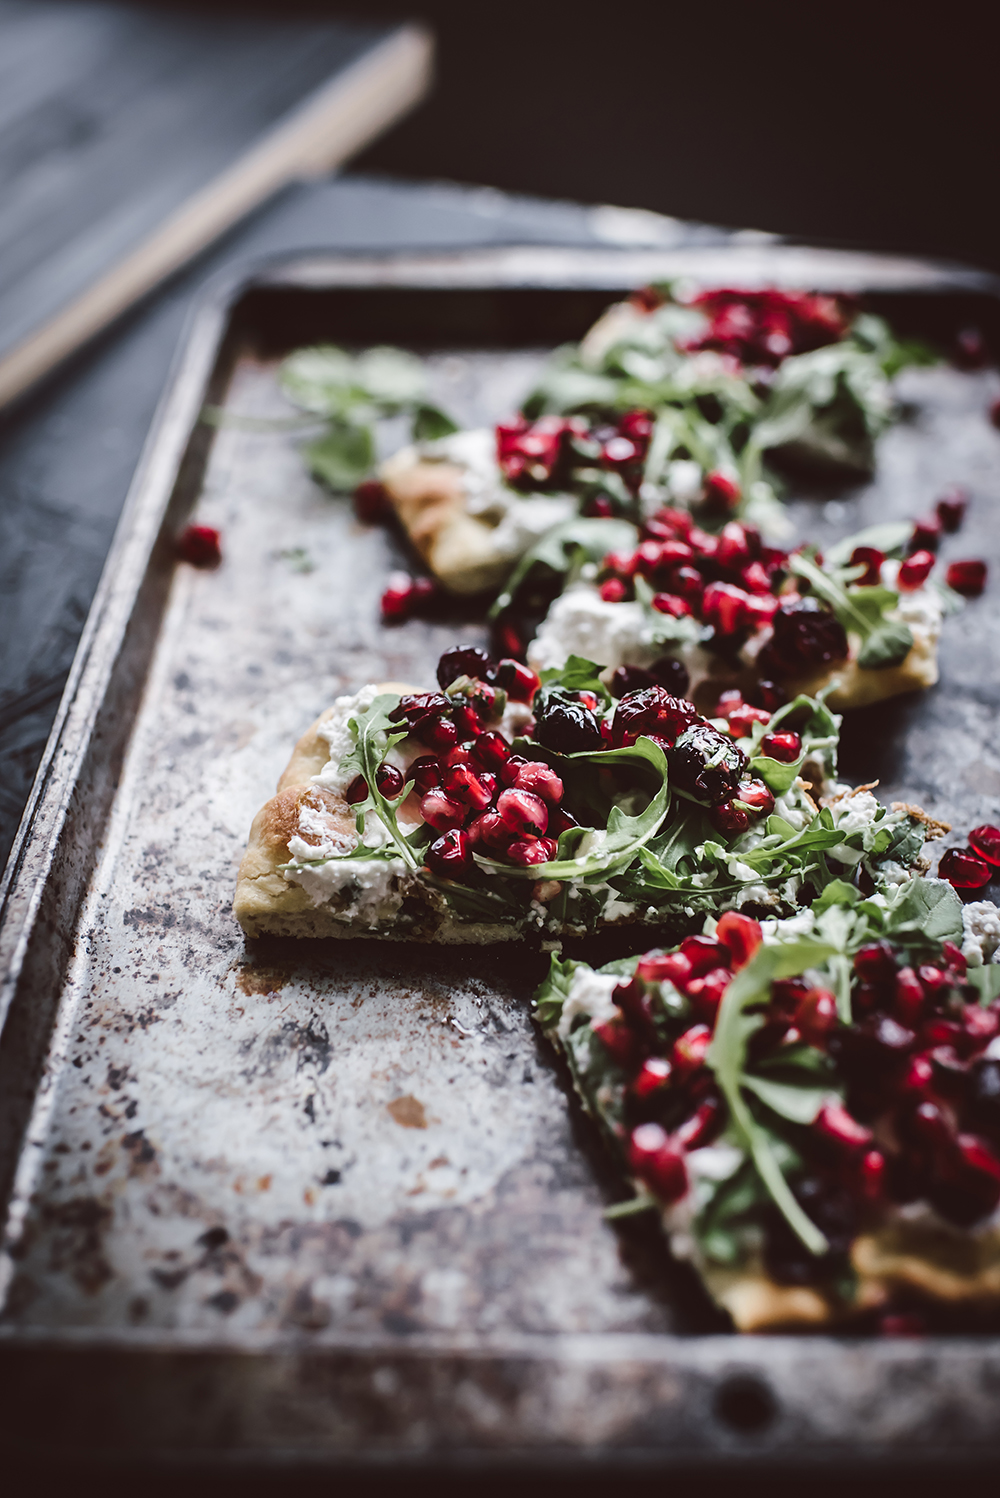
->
xmin=683 ymin=289 xmax=849 ymax=369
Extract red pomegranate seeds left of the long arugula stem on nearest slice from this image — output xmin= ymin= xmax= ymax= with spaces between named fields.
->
xmin=591 ymin=911 xmax=760 ymax=1203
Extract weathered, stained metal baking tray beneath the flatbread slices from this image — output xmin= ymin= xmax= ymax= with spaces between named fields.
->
xmin=0 ymin=244 xmax=1000 ymax=1465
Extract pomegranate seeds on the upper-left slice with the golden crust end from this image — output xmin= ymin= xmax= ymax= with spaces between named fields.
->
xmin=497 ymin=410 xmax=654 ymax=497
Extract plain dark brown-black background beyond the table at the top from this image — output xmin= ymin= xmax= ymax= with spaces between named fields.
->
xmin=150 ymin=0 xmax=1000 ymax=268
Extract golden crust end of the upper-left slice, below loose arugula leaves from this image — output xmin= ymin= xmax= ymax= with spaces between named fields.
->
xmin=379 ymin=448 xmax=510 ymax=593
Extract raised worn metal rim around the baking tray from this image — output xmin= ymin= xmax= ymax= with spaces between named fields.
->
xmin=0 ymin=243 xmax=1000 ymax=1461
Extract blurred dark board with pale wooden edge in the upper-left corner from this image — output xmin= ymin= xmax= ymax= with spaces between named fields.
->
xmin=0 ymin=0 xmax=433 ymax=406
